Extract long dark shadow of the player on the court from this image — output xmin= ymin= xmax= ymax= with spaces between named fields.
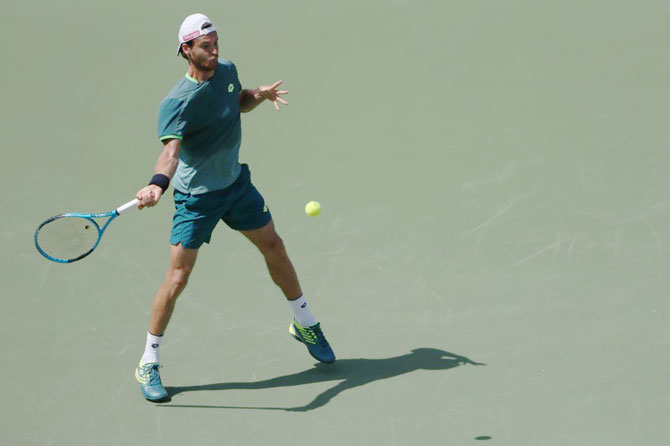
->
xmin=163 ymin=348 xmax=486 ymax=412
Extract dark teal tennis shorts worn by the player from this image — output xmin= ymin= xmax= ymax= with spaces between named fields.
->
xmin=170 ymin=164 xmax=272 ymax=249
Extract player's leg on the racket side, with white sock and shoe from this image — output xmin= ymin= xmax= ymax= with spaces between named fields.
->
xmin=135 ymin=245 xmax=198 ymax=401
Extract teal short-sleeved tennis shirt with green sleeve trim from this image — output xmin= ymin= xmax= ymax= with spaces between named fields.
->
xmin=158 ymin=59 xmax=242 ymax=195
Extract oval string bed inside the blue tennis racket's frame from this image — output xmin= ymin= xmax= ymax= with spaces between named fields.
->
xmin=37 ymin=217 xmax=99 ymax=260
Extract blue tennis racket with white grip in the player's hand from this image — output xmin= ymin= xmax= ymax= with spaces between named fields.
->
xmin=35 ymin=199 xmax=137 ymax=263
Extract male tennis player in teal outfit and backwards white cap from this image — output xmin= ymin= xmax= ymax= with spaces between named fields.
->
xmin=135 ymin=14 xmax=335 ymax=401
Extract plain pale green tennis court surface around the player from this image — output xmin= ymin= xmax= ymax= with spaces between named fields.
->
xmin=0 ymin=0 xmax=670 ymax=446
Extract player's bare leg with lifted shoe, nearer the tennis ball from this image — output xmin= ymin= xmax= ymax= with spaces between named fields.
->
xmin=241 ymin=221 xmax=335 ymax=363
